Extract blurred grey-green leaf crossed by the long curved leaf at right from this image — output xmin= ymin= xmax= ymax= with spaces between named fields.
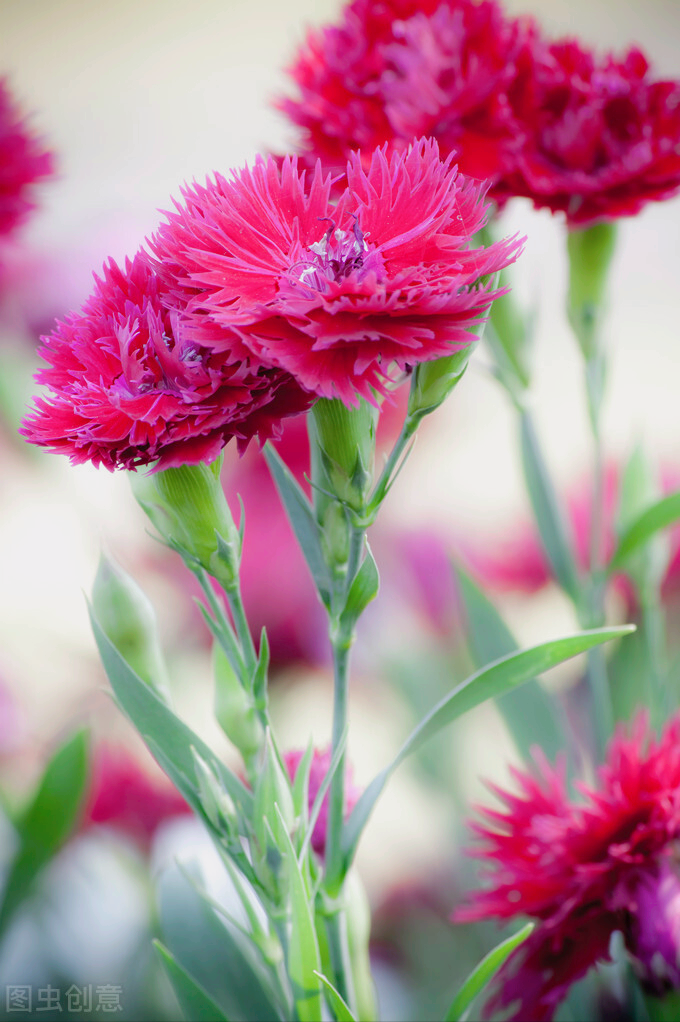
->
xmin=455 ymin=567 xmax=566 ymax=759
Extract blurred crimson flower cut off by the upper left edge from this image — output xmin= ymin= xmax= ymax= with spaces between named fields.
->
xmin=0 ymin=79 xmax=54 ymax=235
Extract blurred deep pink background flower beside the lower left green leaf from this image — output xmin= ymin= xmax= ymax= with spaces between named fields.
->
xmin=83 ymin=745 xmax=191 ymax=849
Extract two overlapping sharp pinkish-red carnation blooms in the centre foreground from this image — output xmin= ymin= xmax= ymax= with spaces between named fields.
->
xmin=22 ymin=140 xmax=522 ymax=469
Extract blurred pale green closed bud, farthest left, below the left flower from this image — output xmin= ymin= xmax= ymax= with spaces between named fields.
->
xmin=92 ymin=553 xmax=168 ymax=699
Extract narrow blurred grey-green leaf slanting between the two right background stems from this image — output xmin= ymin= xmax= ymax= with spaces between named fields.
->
xmin=520 ymin=411 xmax=581 ymax=604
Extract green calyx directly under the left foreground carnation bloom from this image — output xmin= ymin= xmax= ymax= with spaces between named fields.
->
xmin=131 ymin=458 xmax=240 ymax=589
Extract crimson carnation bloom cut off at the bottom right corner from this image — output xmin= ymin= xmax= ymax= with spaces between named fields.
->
xmin=454 ymin=713 xmax=680 ymax=1022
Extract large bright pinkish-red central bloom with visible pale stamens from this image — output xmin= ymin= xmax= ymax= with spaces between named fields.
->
xmin=151 ymin=139 xmax=522 ymax=405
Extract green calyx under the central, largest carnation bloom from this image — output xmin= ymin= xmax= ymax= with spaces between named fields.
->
xmin=310 ymin=398 xmax=378 ymax=512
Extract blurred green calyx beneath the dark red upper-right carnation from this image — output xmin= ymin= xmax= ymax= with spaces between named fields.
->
xmin=566 ymin=222 xmax=617 ymax=362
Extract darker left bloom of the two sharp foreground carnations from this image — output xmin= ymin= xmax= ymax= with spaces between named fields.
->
xmin=21 ymin=252 xmax=312 ymax=469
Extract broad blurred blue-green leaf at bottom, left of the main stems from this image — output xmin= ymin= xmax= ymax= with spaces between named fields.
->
xmin=156 ymin=865 xmax=288 ymax=1022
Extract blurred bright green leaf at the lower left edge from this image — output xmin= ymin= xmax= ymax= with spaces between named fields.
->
xmin=0 ymin=731 xmax=88 ymax=933
